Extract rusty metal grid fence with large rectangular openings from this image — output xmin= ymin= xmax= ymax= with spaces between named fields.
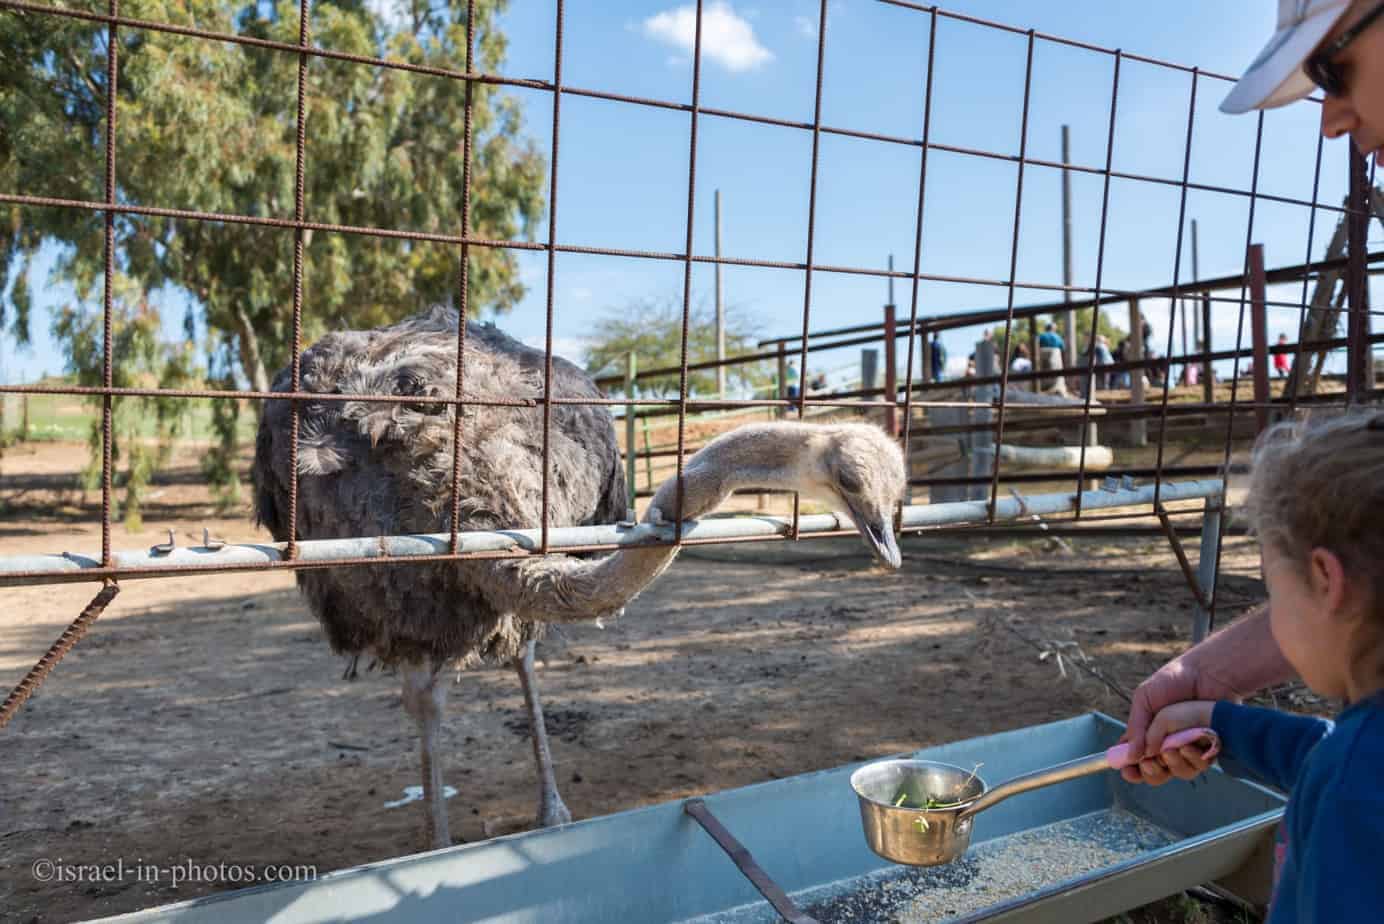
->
xmin=0 ymin=0 xmax=1380 ymax=584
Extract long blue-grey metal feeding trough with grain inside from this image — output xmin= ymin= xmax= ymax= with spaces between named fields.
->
xmin=86 ymin=714 xmax=1284 ymax=924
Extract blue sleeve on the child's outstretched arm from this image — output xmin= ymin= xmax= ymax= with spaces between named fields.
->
xmin=1211 ymin=703 xmax=1333 ymax=793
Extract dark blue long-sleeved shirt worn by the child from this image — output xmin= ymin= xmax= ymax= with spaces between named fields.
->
xmin=1211 ymin=694 xmax=1384 ymax=924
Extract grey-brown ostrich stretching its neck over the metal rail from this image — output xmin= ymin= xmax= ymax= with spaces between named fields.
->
xmin=253 ymin=308 xmax=905 ymax=848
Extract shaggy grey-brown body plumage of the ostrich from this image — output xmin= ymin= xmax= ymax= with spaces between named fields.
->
xmin=255 ymin=308 xmax=626 ymax=664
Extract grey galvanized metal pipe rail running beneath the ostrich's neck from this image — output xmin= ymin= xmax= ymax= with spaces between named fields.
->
xmin=0 ymin=479 xmax=1225 ymax=586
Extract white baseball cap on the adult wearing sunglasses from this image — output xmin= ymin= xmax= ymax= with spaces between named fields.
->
xmin=1221 ymin=0 xmax=1351 ymax=113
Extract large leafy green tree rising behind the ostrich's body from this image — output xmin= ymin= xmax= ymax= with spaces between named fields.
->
xmin=0 ymin=0 xmax=547 ymax=520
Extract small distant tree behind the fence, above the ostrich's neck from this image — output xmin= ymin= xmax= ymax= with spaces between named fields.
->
xmin=584 ymin=297 xmax=774 ymax=397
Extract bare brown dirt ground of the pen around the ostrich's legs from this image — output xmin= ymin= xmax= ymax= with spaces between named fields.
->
xmin=0 ymin=444 xmax=1284 ymax=924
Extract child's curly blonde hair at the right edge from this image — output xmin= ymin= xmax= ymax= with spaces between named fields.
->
xmin=1244 ymin=411 xmax=1384 ymax=616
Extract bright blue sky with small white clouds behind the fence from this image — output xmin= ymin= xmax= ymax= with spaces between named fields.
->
xmin=3 ymin=0 xmax=1378 ymax=380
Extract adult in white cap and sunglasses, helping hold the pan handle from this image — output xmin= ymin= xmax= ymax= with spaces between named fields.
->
xmin=1124 ymin=0 xmax=1384 ymax=785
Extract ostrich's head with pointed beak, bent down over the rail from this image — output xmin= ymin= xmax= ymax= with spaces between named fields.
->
xmin=812 ymin=423 xmax=908 ymax=569
